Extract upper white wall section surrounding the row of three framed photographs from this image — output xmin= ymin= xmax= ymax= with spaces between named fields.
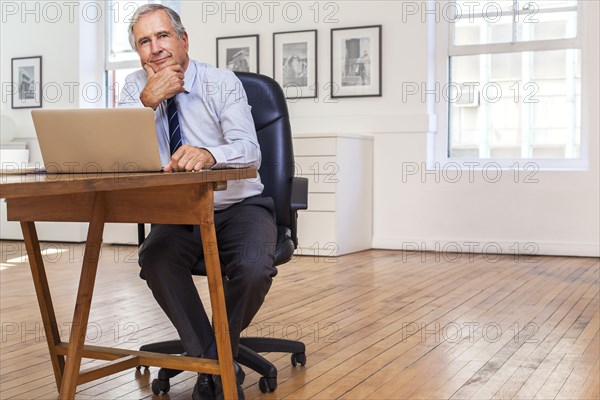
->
xmin=182 ymin=1 xmax=427 ymax=133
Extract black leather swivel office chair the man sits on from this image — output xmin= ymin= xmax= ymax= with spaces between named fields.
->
xmin=139 ymin=72 xmax=308 ymax=394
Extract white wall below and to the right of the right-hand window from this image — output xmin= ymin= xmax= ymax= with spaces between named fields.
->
xmin=373 ymin=2 xmax=600 ymax=256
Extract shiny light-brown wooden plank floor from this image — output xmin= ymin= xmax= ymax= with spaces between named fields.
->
xmin=0 ymin=242 xmax=600 ymax=400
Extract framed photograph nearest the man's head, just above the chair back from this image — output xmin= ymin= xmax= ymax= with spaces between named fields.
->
xmin=217 ymin=35 xmax=259 ymax=73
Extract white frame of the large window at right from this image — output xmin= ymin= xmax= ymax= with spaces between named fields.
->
xmin=426 ymin=0 xmax=590 ymax=171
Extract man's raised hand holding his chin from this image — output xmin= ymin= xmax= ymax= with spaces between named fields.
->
xmin=140 ymin=64 xmax=184 ymax=110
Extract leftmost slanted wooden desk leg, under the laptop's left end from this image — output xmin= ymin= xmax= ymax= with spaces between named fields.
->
xmin=21 ymin=221 xmax=65 ymax=390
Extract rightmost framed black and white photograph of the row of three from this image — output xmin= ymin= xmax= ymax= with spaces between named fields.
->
xmin=331 ymin=25 xmax=381 ymax=98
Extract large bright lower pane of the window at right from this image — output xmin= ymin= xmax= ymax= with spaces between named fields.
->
xmin=448 ymin=49 xmax=581 ymax=158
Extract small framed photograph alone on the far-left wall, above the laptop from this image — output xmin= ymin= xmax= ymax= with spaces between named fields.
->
xmin=11 ymin=56 xmax=42 ymax=108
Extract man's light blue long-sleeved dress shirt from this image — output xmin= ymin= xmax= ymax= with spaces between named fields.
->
xmin=119 ymin=60 xmax=263 ymax=210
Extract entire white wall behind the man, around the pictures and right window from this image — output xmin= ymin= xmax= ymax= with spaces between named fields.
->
xmin=0 ymin=1 xmax=600 ymax=256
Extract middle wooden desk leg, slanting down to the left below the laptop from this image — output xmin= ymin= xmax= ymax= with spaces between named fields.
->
xmin=59 ymin=192 xmax=104 ymax=400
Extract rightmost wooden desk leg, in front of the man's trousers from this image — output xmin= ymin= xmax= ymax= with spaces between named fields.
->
xmin=200 ymin=185 xmax=238 ymax=400
